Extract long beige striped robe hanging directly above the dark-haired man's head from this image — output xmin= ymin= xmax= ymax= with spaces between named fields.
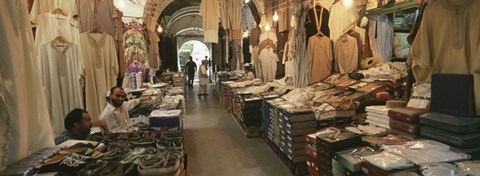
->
xmin=40 ymin=42 xmax=84 ymax=134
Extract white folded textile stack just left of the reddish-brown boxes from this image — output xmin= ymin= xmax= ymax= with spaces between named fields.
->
xmin=366 ymin=106 xmax=390 ymax=129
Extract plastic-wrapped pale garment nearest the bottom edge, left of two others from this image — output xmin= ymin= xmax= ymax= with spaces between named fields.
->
xmin=363 ymin=152 xmax=413 ymax=170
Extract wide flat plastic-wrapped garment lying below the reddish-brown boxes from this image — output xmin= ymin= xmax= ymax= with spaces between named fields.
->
xmin=382 ymin=140 xmax=470 ymax=165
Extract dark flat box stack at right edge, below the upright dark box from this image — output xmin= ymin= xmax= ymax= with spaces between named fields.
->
xmin=420 ymin=112 xmax=480 ymax=158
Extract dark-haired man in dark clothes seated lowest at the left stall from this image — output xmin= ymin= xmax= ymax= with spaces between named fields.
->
xmin=55 ymin=109 xmax=109 ymax=145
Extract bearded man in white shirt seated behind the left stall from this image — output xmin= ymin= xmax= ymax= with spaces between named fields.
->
xmin=100 ymin=87 xmax=152 ymax=133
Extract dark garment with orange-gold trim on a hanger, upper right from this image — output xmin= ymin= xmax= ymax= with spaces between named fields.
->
xmin=305 ymin=5 xmax=330 ymax=46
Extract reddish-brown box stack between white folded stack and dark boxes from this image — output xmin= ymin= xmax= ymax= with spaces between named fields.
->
xmin=388 ymin=107 xmax=426 ymax=139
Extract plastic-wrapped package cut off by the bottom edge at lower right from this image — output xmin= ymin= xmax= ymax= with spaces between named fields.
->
xmin=420 ymin=163 xmax=467 ymax=176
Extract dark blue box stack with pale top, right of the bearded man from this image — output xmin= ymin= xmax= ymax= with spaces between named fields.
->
xmin=149 ymin=110 xmax=182 ymax=129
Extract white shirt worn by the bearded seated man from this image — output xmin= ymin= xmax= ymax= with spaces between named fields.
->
xmin=100 ymin=100 xmax=140 ymax=133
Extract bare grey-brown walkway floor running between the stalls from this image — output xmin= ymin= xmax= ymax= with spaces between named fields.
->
xmin=184 ymin=85 xmax=291 ymax=176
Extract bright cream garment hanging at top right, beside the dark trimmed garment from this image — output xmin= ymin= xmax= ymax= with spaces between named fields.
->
xmin=328 ymin=1 xmax=358 ymax=41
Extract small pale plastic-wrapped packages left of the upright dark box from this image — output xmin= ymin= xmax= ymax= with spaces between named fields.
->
xmin=407 ymin=83 xmax=432 ymax=109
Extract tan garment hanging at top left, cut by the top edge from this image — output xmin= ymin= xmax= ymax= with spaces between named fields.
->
xmin=73 ymin=0 xmax=121 ymax=39
